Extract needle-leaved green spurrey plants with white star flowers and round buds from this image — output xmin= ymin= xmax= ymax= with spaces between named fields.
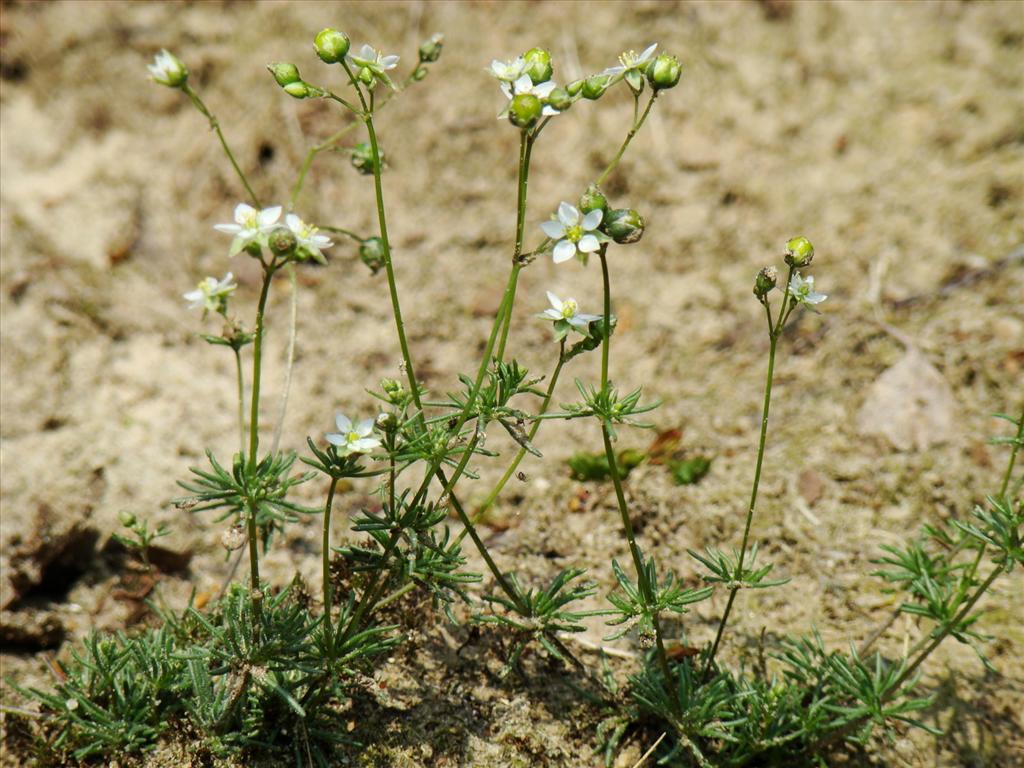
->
xmin=9 ymin=29 xmax=1024 ymax=766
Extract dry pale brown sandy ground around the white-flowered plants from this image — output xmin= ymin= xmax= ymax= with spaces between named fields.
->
xmin=0 ymin=2 xmax=1024 ymax=766
